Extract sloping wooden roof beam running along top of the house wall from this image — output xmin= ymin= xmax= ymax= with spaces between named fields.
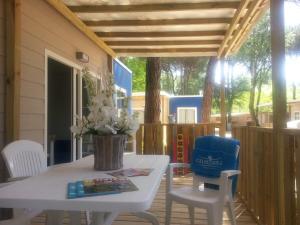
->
xmin=46 ymin=0 xmax=116 ymax=58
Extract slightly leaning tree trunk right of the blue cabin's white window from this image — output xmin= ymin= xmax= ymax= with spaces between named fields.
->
xmin=201 ymin=57 xmax=217 ymax=123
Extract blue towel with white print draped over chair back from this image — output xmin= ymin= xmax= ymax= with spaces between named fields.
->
xmin=191 ymin=136 xmax=240 ymax=193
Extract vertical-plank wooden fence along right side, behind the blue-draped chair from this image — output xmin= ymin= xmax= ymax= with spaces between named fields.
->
xmin=232 ymin=127 xmax=300 ymax=225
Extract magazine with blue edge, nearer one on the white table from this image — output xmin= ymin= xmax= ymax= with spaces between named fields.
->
xmin=67 ymin=178 xmax=138 ymax=199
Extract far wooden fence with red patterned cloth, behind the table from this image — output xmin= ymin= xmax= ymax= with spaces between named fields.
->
xmin=136 ymin=123 xmax=219 ymax=155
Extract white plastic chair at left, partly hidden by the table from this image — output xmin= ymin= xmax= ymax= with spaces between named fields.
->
xmin=0 ymin=140 xmax=47 ymax=225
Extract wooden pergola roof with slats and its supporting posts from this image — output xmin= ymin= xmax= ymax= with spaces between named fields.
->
xmin=5 ymin=0 xmax=290 ymax=225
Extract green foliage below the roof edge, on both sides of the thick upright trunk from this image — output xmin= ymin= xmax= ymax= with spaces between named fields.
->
xmin=120 ymin=57 xmax=207 ymax=95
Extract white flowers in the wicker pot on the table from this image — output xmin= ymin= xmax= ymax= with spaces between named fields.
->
xmin=71 ymin=70 xmax=139 ymax=137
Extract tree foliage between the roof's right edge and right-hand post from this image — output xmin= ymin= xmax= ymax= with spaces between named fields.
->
xmin=233 ymin=14 xmax=271 ymax=125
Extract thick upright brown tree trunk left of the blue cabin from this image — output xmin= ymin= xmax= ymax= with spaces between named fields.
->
xmin=144 ymin=57 xmax=160 ymax=123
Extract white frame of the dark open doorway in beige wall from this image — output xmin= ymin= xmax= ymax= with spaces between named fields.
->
xmin=44 ymin=49 xmax=82 ymax=161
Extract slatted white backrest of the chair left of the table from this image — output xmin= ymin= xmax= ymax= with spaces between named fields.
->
xmin=2 ymin=140 xmax=47 ymax=178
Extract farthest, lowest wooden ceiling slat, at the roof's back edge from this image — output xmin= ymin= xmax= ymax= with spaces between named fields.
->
xmin=114 ymin=48 xmax=218 ymax=53
